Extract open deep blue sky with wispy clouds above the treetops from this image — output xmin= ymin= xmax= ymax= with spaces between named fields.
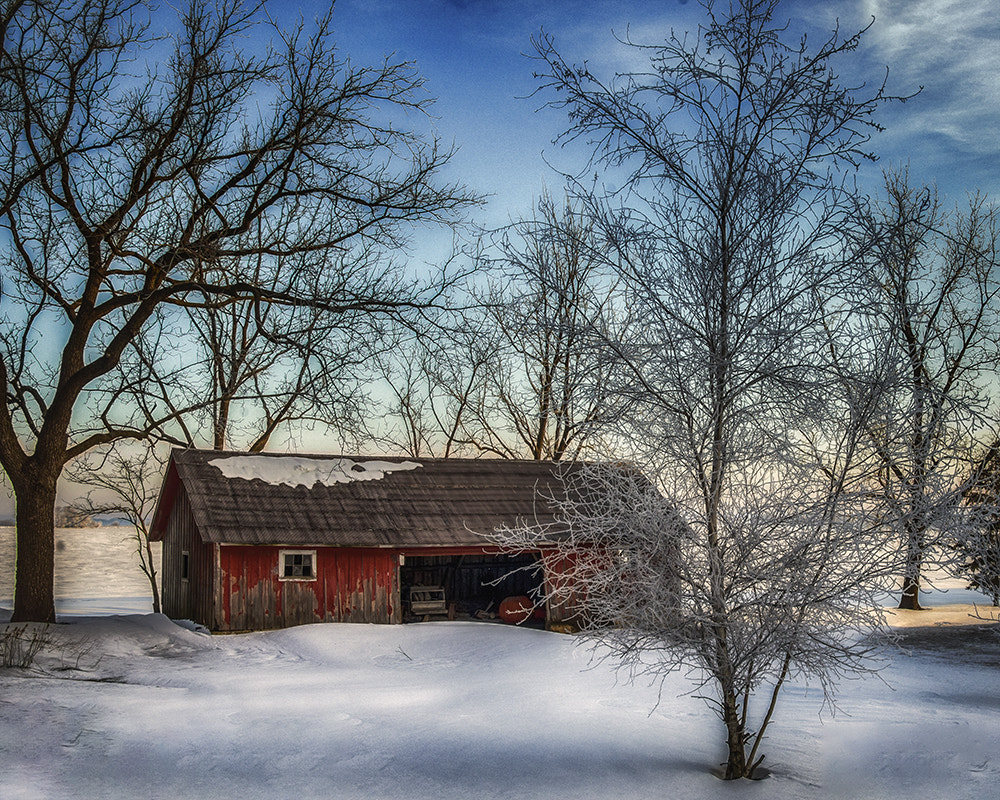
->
xmin=306 ymin=0 xmax=1000 ymax=239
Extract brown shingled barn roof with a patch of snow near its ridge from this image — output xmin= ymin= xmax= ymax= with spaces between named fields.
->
xmin=145 ymin=450 xmax=576 ymax=547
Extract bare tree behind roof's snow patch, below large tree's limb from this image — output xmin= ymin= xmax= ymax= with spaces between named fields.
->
xmin=184 ymin=247 xmax=390 ymax=452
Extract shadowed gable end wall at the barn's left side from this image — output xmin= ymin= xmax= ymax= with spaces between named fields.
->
xmin=161 ymin=487 xmax=216 ymax=628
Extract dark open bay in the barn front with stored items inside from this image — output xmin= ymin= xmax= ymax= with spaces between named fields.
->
xmin=399 ymin=553 xmax=545 ymax=627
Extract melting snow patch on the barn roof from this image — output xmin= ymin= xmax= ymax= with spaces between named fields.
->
xmin=208 ymin=456 xmax=423 ymax=488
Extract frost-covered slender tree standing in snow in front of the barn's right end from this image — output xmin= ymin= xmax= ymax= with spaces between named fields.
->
xmin=500 ymin=0 xmax=908 ymax=778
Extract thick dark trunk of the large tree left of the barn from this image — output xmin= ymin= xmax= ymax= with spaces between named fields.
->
xmin=11 ymin=468 xmax=58 ymax=622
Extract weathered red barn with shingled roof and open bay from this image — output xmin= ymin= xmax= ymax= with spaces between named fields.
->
xmin=151 ymin=450 xmax=584 ymax=631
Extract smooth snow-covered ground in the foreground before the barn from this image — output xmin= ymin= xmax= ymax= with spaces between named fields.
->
xmin=0 ymin=528 xmax=1000 ymax=800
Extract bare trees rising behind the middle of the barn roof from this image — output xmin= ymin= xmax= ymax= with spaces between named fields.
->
xmin=376 ymin=194 xmax=617 ymax=461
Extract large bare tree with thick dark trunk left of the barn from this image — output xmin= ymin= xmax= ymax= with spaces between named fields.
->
xmin=0 ymin=0 xmax=470 ymax=621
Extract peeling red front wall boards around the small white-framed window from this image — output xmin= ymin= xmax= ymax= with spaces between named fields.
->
xmin=217 ymin=545 xmax=402 ymax=631
